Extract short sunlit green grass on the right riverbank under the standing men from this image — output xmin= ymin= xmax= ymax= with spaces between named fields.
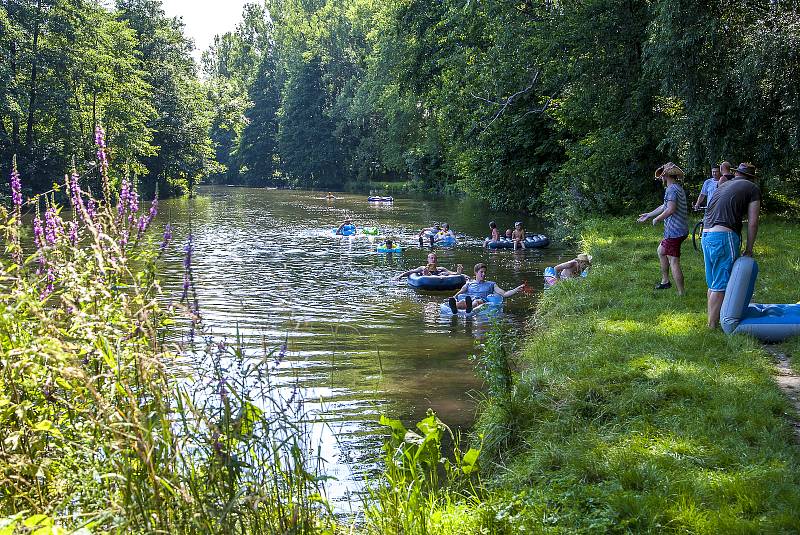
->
xmin=468 ymin=219 xmax=800 ymax=533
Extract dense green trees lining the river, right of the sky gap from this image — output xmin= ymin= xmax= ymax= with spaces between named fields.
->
xmin=205 ymin=0 xmax=800 ymax=219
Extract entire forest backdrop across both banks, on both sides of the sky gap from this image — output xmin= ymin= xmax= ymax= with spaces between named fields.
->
xmin=0 ymin=0 xmax=800 ymax=220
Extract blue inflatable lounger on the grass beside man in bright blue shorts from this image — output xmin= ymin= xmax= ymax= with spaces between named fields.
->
xmin=720 ymin=256 xmax=800 ymax=342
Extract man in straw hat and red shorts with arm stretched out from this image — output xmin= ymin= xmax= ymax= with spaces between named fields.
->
xmin=638 ymin=162 xmax=689 ymax=295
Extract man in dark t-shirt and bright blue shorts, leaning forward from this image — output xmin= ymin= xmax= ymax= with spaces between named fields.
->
xmin=702 ymin=163 xmax=761 ymax=329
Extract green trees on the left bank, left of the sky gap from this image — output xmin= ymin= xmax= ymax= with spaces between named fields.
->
xmin=0 ymin=0 xmax=214 ymax=196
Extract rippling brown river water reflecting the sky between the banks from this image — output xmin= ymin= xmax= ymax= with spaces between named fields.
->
xmin=157 ymin=186 xmax=574 ymax=509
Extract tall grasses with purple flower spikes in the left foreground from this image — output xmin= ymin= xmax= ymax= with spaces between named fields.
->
xmin=0 ymin=149 xmax=336 ymax=534
